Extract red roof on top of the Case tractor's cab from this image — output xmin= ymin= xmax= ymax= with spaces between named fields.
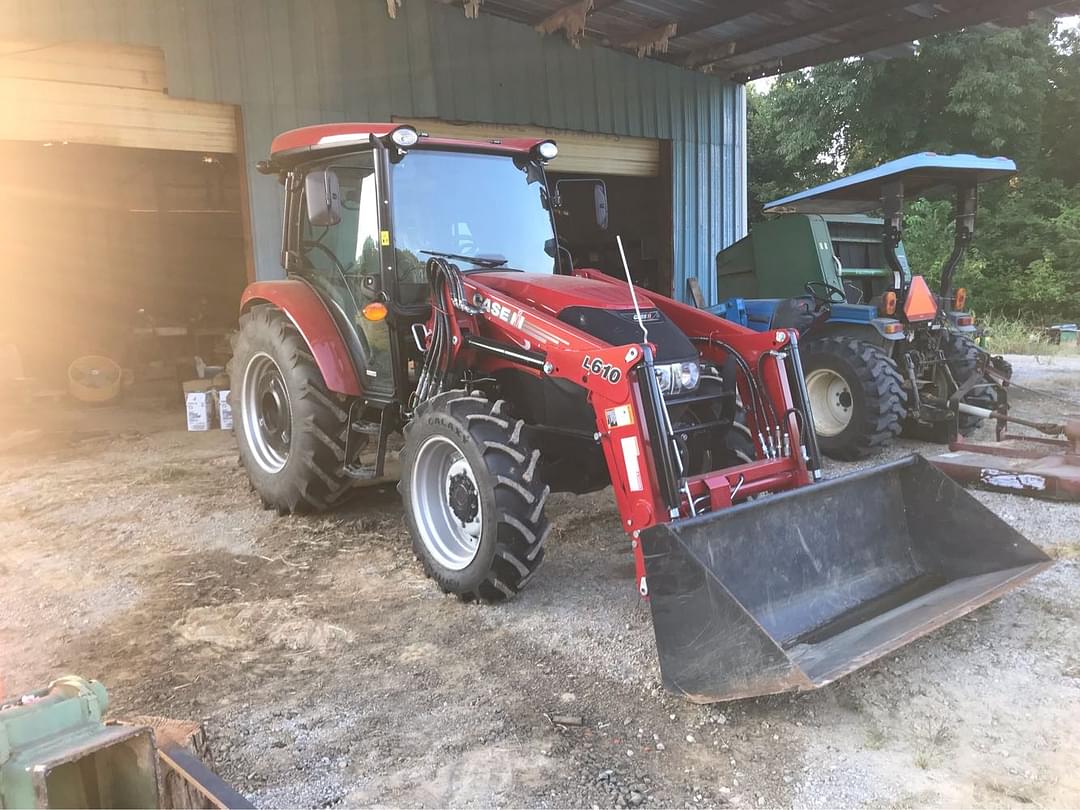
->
xmin=270 ymin=122 xmax=551 ymax=168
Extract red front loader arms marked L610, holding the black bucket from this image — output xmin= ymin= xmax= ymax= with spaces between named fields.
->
xmin=427 ymin=273 xmax=812 ymax=595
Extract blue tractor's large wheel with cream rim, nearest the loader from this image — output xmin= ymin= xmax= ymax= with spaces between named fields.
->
xmin=801 ymin=337 xmax=907 ymax=461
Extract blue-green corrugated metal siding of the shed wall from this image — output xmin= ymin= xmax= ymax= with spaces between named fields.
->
xmin=0 ymin=0 xmax=745 ymax=297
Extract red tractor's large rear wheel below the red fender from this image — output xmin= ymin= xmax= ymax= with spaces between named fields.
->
xmin=229 ymin=305 xmax=352 ymax=514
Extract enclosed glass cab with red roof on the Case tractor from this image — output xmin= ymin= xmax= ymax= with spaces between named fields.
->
xmin=253 ymin=124 xmax=569 ymax=412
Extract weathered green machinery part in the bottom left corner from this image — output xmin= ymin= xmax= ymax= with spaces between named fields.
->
xmin=0 ymin=675 xmax=158 ymax=808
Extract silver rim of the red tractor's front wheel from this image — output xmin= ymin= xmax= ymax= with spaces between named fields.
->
xmin=409 ymin=435 xmax=484 ymax=571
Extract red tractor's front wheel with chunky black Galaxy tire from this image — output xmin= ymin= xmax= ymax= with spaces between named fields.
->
xmin=397 ymin=390 xmax=551 ymax=603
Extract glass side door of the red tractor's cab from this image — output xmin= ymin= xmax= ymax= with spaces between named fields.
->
xmin=286 ymin=151 xmax=395 ymax=401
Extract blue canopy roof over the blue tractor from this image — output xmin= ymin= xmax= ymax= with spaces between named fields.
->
xmin=765 ymin=152 xmax=1016 ymax=214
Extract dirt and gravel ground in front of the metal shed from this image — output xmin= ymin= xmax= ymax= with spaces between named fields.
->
xmin=0 ymin=357 xmax=1080 ymax=808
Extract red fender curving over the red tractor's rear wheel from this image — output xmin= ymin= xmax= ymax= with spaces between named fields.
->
xmin=240 ymin=279 xmax=363 ymax=396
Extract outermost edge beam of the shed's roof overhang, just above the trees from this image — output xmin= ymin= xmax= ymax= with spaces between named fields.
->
xmin=730 ymin=0 xmax=1047 ymax=82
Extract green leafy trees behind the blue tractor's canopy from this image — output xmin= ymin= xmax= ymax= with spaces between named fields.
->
xmin=748 ymin=23 xmax=1080 ymax=320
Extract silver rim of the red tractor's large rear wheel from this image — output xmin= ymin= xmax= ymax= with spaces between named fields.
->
xmin=241 ymin=352 xmax=293 ymax=474
